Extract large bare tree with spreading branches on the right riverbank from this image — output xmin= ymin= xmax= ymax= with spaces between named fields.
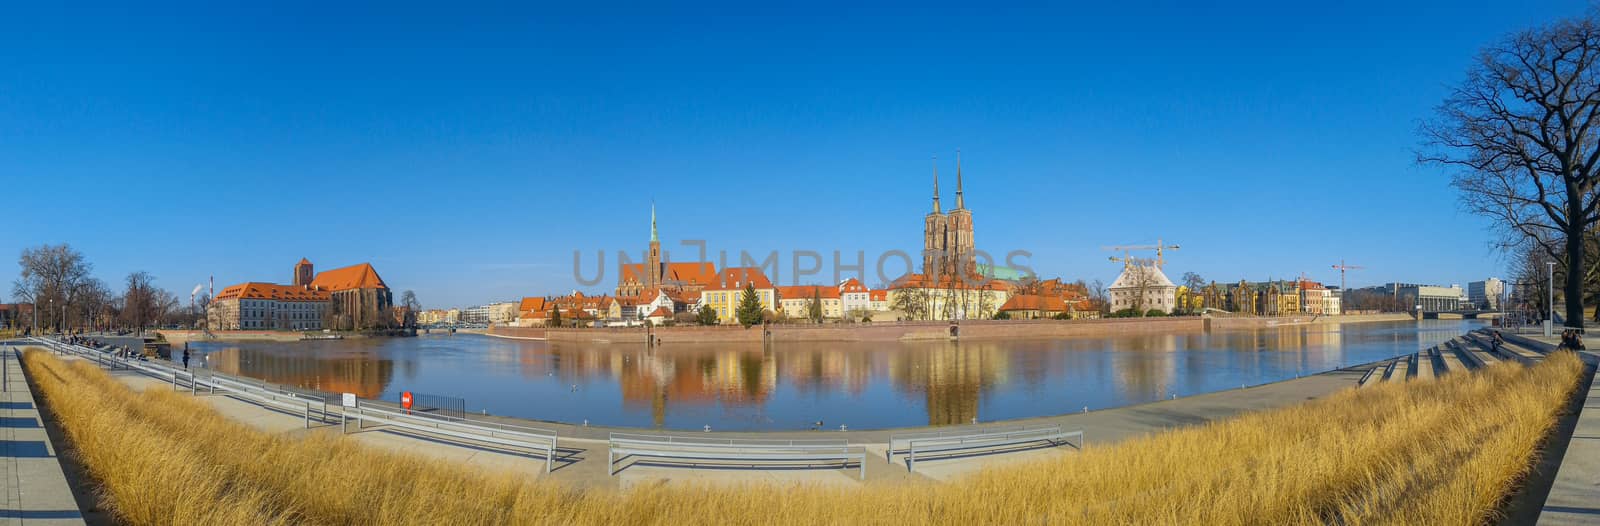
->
xmin=1418 ymin=16 xmax=1600 ymax=328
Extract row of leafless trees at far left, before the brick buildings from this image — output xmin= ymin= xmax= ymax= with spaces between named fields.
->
xmin=11 ymin=243 xmax=187 ymax=331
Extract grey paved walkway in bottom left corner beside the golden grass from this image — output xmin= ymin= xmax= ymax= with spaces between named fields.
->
xmin=0 ymin=345 xmax=83 ymax=524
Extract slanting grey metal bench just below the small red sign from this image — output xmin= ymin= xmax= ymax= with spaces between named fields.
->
xmin=341 ymin=403 xmax=557 ymax=473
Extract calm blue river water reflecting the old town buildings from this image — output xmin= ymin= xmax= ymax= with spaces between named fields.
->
xmin=181 ymin=320 xmax=1480 ymax=430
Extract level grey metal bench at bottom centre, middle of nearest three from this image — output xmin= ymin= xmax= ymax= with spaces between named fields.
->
xmin=606 ymin=433 xmax=867 ymax=480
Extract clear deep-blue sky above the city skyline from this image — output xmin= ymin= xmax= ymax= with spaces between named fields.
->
xmin=0 ymin=0 xmax=1587 ymax=307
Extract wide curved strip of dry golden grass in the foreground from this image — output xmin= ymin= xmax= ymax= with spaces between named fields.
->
xmin=27 ymin=343 xmax=1582 ymax=524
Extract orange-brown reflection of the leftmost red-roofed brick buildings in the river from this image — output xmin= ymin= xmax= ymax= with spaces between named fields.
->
xmin=206 ymin=347 xmax=395 ymax=398
